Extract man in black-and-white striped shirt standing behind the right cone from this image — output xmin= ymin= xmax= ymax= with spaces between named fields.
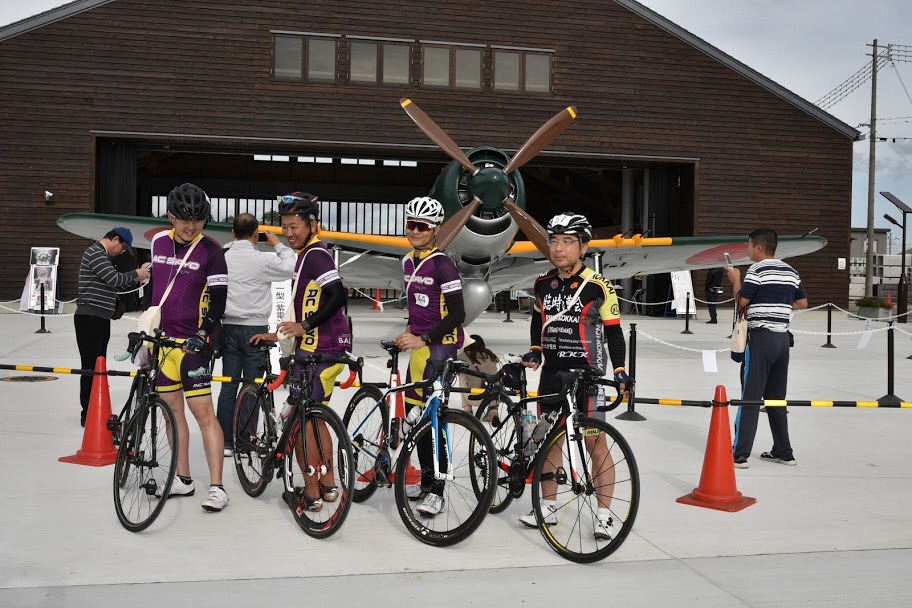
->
xmin=728 ymin=228 xmax=807 ymax=469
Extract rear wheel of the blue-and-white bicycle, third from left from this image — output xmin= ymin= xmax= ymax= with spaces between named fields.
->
xmin=342 ymin=386 xmax=389 ymax=502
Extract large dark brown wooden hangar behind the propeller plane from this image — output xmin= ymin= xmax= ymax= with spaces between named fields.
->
xmin=0 ymin=0 xmax=858 ymax=305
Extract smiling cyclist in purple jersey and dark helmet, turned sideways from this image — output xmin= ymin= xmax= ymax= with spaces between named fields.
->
xmin=250 ymin=192 xmax=352 ymax=511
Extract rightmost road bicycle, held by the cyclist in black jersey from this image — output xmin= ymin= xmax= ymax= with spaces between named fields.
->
xmin=476 ymin=362 xmax=640 ymax=563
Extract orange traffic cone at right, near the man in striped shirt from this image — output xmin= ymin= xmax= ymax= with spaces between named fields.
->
xmin=677 ymin=385 xmax=757 ymax=512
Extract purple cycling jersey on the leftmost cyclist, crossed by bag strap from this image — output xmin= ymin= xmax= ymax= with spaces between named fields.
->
xmin=152 ymin=230 xmax=228 ymax=338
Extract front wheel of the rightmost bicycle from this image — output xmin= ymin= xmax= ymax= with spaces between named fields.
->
xmin=532 ymin=418 xmax=640 ymax=563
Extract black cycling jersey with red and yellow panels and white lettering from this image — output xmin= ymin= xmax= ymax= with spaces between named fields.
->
xmin=531 ymin=266 xmax=626 ymax=374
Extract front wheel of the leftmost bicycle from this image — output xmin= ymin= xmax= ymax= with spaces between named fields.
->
xmin=114 ymin=398 xmax=177 ymax=532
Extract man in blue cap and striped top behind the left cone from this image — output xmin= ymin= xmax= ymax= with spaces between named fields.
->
xmin=73 ymin=226 xmax=149 ymax=426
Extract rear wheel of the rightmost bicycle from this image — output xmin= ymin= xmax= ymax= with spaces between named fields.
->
xmin=472 ymin=395 xmax=526 ymax=514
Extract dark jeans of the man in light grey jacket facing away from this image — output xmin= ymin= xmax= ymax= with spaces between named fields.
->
xmin=216 ymin=325 xmax=269 ymax=446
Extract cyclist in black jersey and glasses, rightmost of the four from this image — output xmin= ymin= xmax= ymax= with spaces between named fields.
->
xmin=519 ymin=212 xmax=630 ymax=540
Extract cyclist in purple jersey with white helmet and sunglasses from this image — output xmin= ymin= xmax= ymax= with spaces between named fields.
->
xmin=395 ymin=196 xmax=465 ymax=517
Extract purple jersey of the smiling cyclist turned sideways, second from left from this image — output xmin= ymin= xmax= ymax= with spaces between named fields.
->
xmin=293 ymin=236 xmax=352 ymax=353
